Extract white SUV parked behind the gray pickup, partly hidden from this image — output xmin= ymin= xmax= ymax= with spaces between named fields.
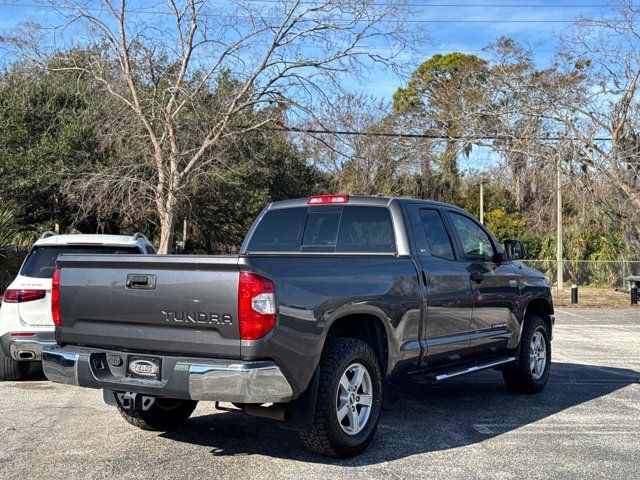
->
xmin=0 ymin=232 xmax=156 ymax=380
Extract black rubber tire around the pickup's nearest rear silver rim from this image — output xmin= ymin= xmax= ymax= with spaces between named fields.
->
xmin=299 ymin=338 xmax=382 ymax=458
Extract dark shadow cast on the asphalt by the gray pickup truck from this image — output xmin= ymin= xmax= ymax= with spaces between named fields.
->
xmin=162 ymin=363 xmax=640 ymax=467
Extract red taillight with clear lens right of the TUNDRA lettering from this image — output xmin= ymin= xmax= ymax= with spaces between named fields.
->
xmin=238 ymin=272 xmax=276 ymax=340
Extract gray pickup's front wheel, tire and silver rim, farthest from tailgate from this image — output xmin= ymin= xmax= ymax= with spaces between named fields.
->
xmin=502 ymin=315 xmax=551 ymax=393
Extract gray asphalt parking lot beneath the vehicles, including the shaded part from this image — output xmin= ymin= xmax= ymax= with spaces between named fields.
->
xmin=0 ymin=308 xmax=640 ymax=480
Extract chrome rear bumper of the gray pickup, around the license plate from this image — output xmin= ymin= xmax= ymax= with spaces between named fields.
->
xmin=42 ymin=346 xmax=293 ymax=404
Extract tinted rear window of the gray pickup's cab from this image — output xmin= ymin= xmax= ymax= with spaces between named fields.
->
xmin=247 ymin=205 xmax=396 ymax=253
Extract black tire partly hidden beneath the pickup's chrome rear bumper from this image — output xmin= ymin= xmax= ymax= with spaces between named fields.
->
xmin=118 ymin=398 xmax=198 ymax=432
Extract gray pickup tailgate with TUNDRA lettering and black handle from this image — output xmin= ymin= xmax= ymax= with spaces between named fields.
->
xmin=56 ymin=255 xmax=240 ymax=357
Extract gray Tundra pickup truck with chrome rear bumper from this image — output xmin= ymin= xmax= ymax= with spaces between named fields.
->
xmin=43 ymin=195 xmax=554 ymax=457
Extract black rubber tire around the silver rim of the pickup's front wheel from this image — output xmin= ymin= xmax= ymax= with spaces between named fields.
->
xmin=502 ymin=315 xmax=551 ymax=393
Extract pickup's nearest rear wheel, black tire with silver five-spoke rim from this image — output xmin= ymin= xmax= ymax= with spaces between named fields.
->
xmin=300 ymin=338 xmax=382 ymax=458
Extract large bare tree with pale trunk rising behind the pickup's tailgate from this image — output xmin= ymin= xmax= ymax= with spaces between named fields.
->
xmin=7 ymin=0 xmax=405 ymax=253
